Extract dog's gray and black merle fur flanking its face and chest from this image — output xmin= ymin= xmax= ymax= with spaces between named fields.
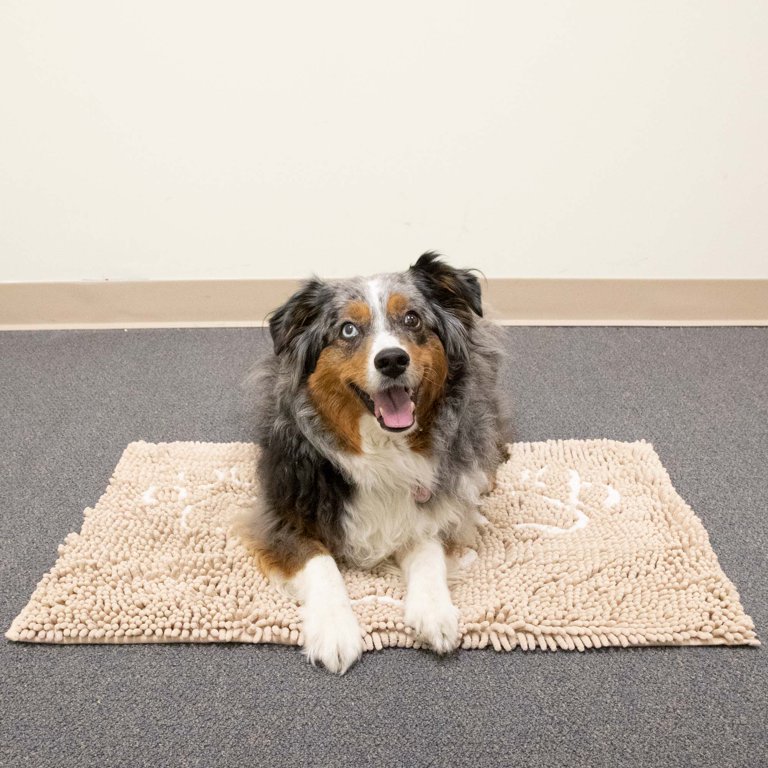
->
xmin=249 ymin=253 xmax=508 ymax=557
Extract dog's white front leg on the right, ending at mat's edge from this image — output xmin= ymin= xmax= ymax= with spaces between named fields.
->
xmin=397 ymin=541 xmax=459 ymax=653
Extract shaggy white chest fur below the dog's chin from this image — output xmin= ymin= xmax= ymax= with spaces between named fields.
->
xmin=340 ymin=418 xmax=456 ymax=567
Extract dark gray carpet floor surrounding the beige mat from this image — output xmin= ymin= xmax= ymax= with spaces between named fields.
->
xmin=0 ymin=328 xmax=768 ymax=768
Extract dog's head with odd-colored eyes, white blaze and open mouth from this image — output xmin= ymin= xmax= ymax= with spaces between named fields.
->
xmin=269 ymin=253 xmax=482 ymax=447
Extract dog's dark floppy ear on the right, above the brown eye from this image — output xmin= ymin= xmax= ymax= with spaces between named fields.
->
xmin=408 ymin=252 xmax=483 ymax=325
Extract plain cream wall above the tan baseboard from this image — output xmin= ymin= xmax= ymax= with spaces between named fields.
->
xmin=0 ymin=0 xmax=768 ymax=281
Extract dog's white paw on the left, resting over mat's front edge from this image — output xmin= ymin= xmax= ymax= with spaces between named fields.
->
xmin=301 ymin=605 xmax=363 ymax=675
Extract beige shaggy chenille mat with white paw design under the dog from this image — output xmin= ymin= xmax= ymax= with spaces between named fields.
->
xmin=6 ymin=440 xmax=759 ymax=651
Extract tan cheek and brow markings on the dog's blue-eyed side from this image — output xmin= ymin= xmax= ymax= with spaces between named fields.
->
xmin=308 ymin=312 xmax=371 ymax=453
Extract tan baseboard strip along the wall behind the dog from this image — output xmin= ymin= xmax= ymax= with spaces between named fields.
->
xmin=0 ymin=278 xmax=768 ymax=330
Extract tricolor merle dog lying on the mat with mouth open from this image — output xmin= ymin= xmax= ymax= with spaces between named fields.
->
xmin=241 ymin=252 xmax=506 ymax=674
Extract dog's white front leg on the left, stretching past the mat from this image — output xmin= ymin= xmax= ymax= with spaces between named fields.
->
xmin=288 ymin=554 xmax=363 ymax=675
